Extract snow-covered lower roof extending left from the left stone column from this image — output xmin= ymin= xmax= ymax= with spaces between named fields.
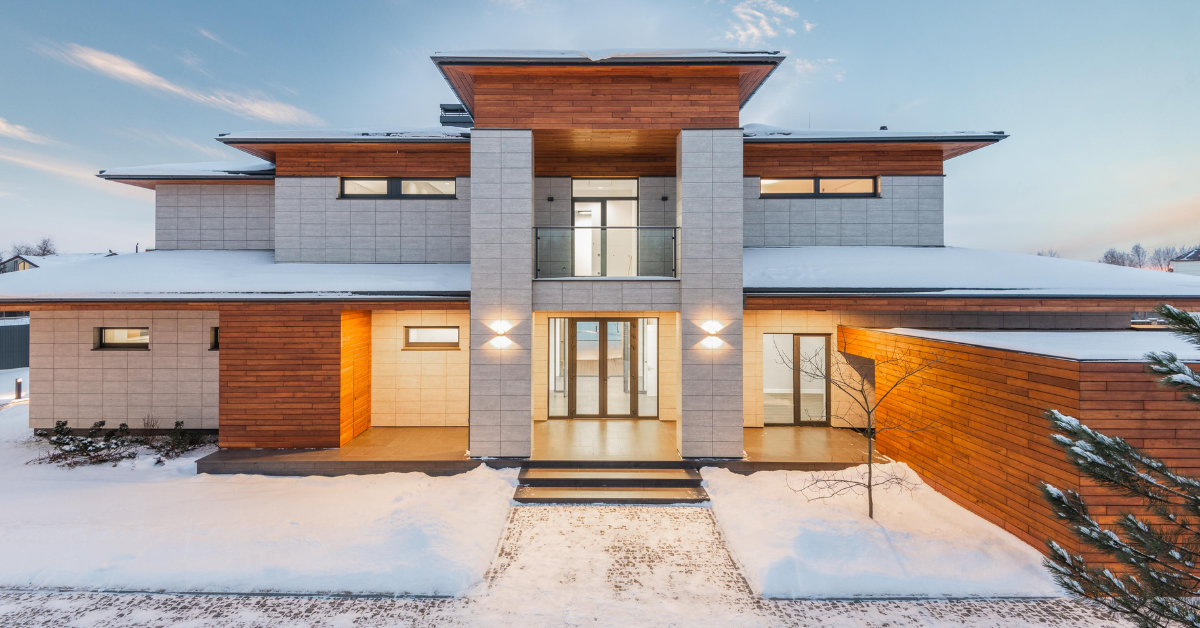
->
xmin=0 ymin=251 xmax=470 ymax=301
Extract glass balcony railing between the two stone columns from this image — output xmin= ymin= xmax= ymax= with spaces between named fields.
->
xmin=533 ymin=227 xmax=679 ymax=279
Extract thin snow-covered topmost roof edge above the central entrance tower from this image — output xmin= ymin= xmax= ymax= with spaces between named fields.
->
xmin=431 ymin=48 xmax=784 ymax=64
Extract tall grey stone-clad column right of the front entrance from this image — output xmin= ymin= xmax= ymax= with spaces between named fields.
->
xmin=676 ymin=128 xmax=743 ymax=457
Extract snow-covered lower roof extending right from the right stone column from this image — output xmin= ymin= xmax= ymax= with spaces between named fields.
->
xmin=743 ymin=246 xmax=1200 ymax=298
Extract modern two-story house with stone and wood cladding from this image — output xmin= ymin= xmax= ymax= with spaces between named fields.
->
xmin=0 ymin=50 xmax=1200 ymax=559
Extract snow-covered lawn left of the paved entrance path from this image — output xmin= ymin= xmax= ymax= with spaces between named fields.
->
xmin=0 ymin=402 xmax=516 ymax=596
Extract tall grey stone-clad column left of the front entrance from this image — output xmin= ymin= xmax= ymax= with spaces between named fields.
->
xmin=470 ymin=128 xmax=533 ymax=457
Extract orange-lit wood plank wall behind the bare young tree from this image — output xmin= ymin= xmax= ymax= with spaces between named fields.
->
xmin=838 ymin=327 xmax=1200 ymax=561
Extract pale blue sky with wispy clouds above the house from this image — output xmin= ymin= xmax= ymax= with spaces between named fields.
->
xmin=0 ymin=0 xmax=1200 ymax=259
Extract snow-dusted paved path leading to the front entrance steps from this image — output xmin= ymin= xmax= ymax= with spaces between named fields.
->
xmin=0 ymin=506 xmax=1127 ymax=628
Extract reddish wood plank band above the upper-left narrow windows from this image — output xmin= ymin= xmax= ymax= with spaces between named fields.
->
xmin=223 ymin=142 xmax=470 ymax=177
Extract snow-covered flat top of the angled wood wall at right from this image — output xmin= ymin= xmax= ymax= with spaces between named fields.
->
xmin=880 ymin=329 xmax=1200 ymax=361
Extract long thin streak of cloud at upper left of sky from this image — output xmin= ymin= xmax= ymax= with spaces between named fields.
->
xmin=37 ymin=43 xmax=323 ymax=126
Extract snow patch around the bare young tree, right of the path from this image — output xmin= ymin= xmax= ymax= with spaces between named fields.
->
xmin=701 ymin=463 xmax=1062 ymax=598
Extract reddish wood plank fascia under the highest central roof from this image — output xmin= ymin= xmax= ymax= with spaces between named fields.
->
xmin=458 ymin=66 xmax=742 ymax=130
